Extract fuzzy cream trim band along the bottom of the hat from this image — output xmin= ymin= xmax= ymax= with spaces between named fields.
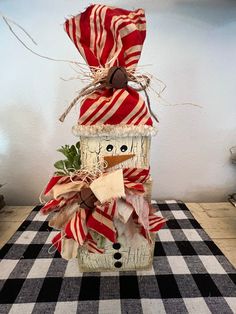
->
xmin=72 ymin=124 xmax=157 ymax=137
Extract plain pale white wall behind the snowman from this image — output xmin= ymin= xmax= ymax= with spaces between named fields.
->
xmin=0 ymin=0 xmax=236 ymax=205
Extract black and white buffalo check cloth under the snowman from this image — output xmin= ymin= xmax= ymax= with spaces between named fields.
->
xmin=0 ymin=201 xmax=236 ymax=314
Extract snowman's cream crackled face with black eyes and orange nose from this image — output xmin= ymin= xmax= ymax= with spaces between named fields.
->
xmin=80 ymin=136 xmax=150 ymax=170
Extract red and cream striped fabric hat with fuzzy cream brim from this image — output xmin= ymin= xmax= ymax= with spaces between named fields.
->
xmin=64 ymin=5 xmax=158 ymax=136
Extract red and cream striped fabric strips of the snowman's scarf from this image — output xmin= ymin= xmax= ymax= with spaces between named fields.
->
xmin=41 ymin=168 xmax=165 ymax=253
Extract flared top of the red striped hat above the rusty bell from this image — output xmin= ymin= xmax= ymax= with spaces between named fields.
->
xmin=64 ymin=4 xmax=146 ymax=67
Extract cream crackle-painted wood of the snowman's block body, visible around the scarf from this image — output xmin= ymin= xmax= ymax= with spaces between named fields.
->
xmin=78 ymin=136 xmax=154 ymax=272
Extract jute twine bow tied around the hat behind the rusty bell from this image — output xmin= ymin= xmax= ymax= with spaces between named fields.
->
xmin=59 ymin=67 xmax=159 ymax=122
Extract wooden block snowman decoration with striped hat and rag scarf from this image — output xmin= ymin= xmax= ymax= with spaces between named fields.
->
xmin=42 ymin=5 xmax=165 ymax=271
